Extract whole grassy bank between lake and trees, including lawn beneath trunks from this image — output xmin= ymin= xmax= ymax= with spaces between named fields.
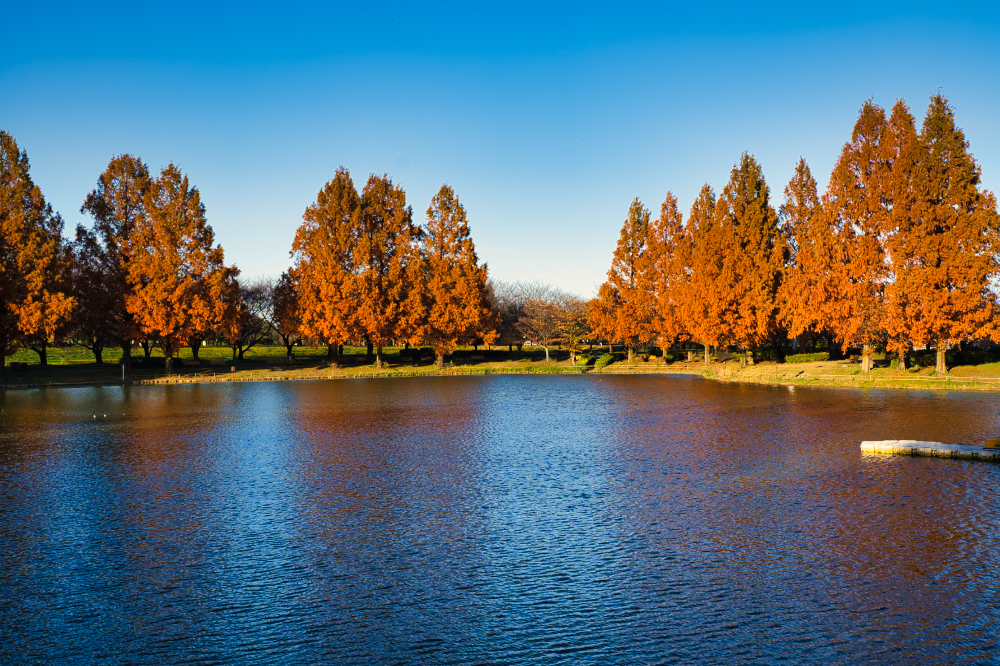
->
xmin=4 ymin=347 xmax=1000 ymax=391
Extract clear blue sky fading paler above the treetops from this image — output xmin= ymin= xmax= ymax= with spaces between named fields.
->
xmin=0 ymin=1 xmax=1000 ymax=296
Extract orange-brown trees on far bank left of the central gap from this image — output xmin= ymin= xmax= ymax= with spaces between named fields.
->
xmin=0 ymin=131 xmax=498 ymax=372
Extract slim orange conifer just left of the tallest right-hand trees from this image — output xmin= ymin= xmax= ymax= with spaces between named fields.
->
xmin=779 ymin=159 xmax=839 ymax=350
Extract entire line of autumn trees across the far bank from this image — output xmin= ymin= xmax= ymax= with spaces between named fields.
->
xmin=0 ymin=96 xmax=1000 ymax=378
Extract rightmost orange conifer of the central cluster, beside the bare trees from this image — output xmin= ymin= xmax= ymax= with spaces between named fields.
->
xmin=410 ymin=185 xmax=496 ymax=368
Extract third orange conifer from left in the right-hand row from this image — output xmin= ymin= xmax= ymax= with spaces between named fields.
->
xmin=674 ymin=184 xmax=729 ymax=364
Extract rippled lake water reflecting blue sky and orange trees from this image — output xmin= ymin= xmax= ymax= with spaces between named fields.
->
xmin=0 ymin=376 xmax=1000 ymax=664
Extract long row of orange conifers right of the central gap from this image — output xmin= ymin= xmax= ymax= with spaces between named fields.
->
xmin=589 ymin=95 xmax=1000 ymax=372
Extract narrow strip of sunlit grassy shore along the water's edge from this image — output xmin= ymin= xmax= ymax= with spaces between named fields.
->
xmin=0 ymin=361 xmax=1000 ymax=392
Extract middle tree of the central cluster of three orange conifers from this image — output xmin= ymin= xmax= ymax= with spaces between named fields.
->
xmin=348 ymin=174 xmax=426 ymax=368
